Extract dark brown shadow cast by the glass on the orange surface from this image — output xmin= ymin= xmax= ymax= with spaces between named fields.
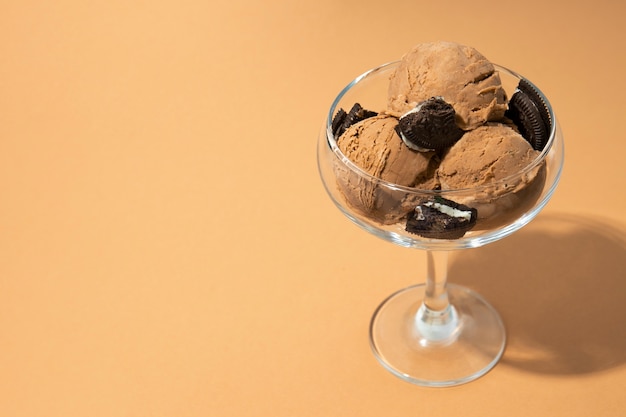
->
xmin=449 ymin=214 xmax=626 ymax=374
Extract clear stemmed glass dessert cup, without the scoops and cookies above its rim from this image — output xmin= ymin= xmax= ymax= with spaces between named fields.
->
xmin=318 ymin=62 xmax=564 ymax=387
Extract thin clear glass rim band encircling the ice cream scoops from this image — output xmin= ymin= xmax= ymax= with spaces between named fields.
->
xmin=324 ymin=61 xmax=557 ymax=196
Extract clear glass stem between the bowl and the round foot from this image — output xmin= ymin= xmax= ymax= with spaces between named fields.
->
xmin=415 ymin=251 xmax=459 ymax=344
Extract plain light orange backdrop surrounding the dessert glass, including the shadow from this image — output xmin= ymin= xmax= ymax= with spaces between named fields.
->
xmin=0 ymin=0 xmax=626 ymax=417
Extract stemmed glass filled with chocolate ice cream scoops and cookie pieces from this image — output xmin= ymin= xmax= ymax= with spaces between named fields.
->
xmin=317 ymin=42 xmax=564 ymax=387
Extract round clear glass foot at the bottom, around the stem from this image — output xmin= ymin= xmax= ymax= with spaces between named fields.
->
xmin=370 ymin=284 xmax=506 ymax=387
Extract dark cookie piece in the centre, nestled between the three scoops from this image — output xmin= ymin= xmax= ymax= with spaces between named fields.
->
xmin=396 ymin=97 xmax=463 ymax=151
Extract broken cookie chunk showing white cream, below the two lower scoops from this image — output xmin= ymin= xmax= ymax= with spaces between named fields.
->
xmin=406 ymin=196 xmax=478 ymax=239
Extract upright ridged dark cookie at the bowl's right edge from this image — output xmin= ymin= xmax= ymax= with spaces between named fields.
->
xmin=504 ymin=80 xmax=552 ymax=151
